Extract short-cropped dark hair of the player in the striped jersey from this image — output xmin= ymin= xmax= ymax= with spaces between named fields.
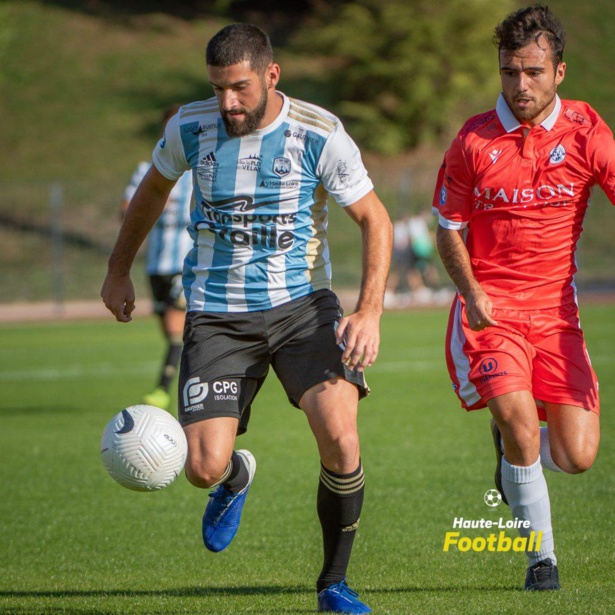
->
xmin=205 ymin=23 xmax=273 ymax=74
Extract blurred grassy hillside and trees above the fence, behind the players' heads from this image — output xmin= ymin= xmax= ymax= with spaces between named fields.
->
xmin=0 ymin=0 xmax=615 ymax=186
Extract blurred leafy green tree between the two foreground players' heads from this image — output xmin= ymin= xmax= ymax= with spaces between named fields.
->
xmin=293 ymin=0 xmax=515 ymax=154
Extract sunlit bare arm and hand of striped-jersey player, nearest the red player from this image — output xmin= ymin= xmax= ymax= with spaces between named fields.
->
xmin=337 ymin=190 xmax=393 ymax=370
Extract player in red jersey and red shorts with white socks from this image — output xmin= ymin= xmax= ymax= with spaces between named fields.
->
xmin=434 ymin=5 xmax=615 ymax=590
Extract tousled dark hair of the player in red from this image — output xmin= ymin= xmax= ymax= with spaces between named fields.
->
xmin=493 ymin=4 xmax=566 ymax=68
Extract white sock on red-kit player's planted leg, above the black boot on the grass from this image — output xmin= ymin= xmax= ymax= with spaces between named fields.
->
xmin=502 ymin=457 xmax=557 ymax=566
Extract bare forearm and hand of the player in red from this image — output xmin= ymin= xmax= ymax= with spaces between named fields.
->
xmin=436 ymin=226 xmax=498 ymax=331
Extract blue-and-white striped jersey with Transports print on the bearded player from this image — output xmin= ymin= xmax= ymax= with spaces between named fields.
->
xmin=153 ymin=92 xmax=373 ymax=312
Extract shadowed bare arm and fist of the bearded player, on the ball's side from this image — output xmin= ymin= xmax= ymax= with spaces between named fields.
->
xmin=100 ymin=165 xmax=175 ymax=322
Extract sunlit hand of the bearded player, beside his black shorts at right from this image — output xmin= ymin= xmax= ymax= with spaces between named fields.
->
xmin=336 ymin=311 xmax=380 ymax=372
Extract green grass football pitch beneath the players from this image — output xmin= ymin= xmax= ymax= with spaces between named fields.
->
xmin=0 ymin=305 xmax=615 ymax=615
